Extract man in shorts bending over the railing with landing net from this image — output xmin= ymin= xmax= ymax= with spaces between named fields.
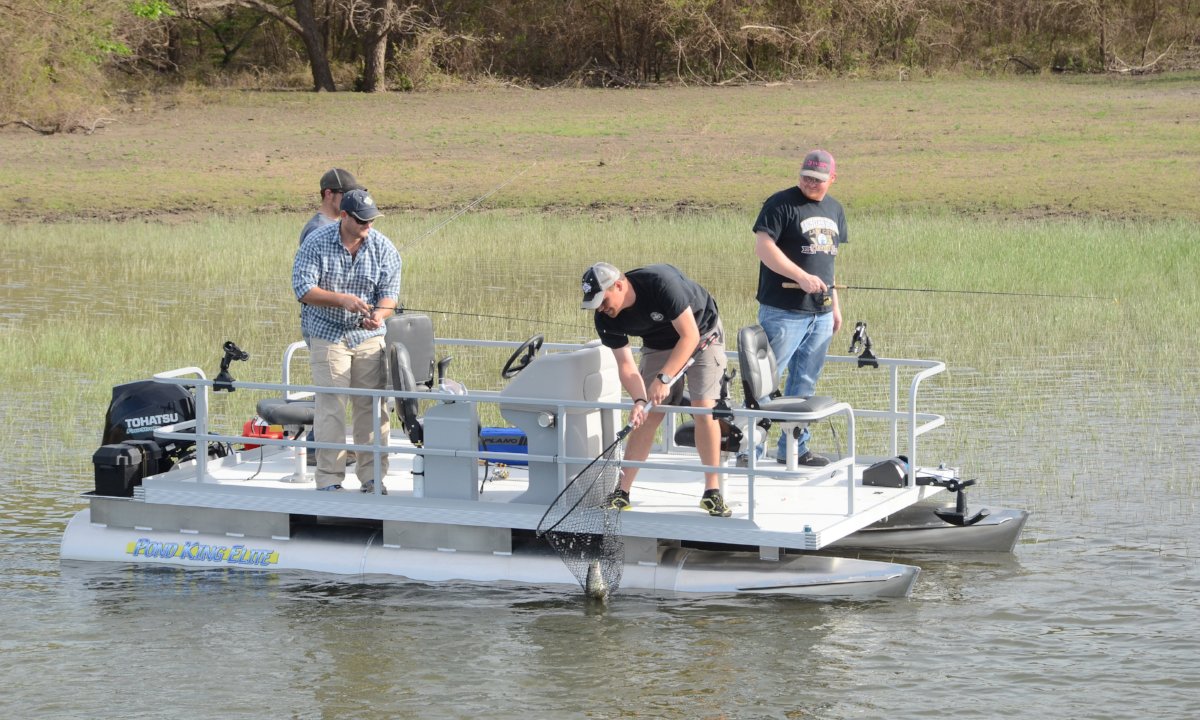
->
xmin=583 ymin=263 xmax=732 ymax=517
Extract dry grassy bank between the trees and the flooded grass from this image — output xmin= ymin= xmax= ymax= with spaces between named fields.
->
xmin=0 ymin=73 xmax=1200 ymax=223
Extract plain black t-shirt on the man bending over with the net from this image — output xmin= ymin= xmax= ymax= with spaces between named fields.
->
xmin=595 ymin=265 xmax=718 ymax=350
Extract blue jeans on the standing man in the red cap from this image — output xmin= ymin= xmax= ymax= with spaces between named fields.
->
xmin=758 ymin=305 xmax=833 ymax=457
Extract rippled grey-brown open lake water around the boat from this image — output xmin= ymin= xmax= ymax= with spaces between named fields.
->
xmin=0 ymin=255 xmax=1200 ymax=720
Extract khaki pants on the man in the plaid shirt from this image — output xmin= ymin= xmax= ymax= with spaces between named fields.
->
xmin=308 ymin=336 xmax=391 ymax=487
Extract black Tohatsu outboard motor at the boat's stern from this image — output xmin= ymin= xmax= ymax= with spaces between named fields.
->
xmin=92 ymin=380 xmax=196 ymax=497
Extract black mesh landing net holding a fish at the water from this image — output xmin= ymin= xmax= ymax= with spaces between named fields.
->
xmin=538 ymin=436 xmax=625 ymax=595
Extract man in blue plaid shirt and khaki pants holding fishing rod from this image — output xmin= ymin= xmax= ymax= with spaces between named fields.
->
xmin=292 ymin=190 xmax=401 ymax=492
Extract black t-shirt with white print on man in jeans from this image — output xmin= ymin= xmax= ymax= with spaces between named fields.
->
xmin=754 ymin=185 xmax=850 ymax=313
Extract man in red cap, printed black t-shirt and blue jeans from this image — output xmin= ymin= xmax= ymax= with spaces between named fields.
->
xmin=754 ymin=150 xmax=850 ymax=467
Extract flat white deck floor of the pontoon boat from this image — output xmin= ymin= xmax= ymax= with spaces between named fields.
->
xmin=134 ymin=437 xmax=948 ymax=554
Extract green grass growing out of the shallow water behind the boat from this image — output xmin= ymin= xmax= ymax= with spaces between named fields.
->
xmin=0 ymin=212 xmax=1200 ymax=427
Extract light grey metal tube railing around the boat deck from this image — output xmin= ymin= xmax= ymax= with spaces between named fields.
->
xmin=142 ymin=338 xmax=946 ymax=520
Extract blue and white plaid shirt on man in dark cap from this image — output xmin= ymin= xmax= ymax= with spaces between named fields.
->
xmin=292 ymin=222 xmax=401 ymax=348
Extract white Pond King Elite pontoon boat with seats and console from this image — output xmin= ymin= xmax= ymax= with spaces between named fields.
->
xmin=61 ymin=313 xmax=1027 ymax=598
